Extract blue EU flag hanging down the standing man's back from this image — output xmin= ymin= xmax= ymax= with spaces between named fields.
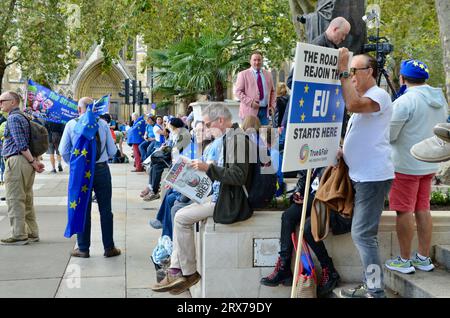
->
xmin=64 ymin=106 xmax=98 ymax=238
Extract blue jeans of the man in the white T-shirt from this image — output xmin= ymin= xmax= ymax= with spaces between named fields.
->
xmin=351 ymin=180 xmax=392 ymax=292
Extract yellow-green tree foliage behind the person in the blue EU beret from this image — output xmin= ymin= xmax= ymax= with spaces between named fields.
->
xmin=368 ymin=0 xmax=445 ymax=87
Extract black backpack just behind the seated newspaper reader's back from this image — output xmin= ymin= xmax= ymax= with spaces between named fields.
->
xmin=248 ymin=134 xmax=277 ymax=209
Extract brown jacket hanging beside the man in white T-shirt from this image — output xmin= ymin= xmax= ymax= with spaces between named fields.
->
xmin=311 ymin=160 xmax=354 ymax=241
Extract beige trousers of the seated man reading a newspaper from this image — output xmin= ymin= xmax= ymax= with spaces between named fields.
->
xmin=170 ymin=201 xmax=215 ymax=276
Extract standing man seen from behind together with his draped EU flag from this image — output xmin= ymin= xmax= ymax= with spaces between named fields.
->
xmin=59 ymin=97 xmax=121 ymax=258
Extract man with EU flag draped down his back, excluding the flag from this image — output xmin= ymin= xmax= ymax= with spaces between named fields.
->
xmin=59 ymin=97 xmax=121 ymax=258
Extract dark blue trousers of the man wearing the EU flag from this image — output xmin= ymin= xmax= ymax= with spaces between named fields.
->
xmin=77 ymin=163 xmax=114 ymax=252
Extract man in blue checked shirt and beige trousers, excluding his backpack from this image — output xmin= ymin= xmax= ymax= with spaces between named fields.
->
xmin=0 ymin=92 xmax=44 ymax=245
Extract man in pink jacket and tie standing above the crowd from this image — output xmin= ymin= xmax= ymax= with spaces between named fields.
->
xmin=234 ymin=52 xmax=276 ymax=125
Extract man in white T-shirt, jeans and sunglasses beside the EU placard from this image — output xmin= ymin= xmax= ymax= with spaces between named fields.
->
xmin=339 ymin=48 xmax=394 ymax=298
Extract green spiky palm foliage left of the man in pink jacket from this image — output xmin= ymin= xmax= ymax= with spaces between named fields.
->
xmin=150 ymin=29 xmax=256 ymax=101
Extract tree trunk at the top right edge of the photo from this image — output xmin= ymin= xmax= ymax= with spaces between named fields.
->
xmin=435 ymin=0 xmax=450 ymax=102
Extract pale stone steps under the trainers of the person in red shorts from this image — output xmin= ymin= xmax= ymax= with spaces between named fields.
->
xmin=384 ymin=267 xmax=450 ymax=298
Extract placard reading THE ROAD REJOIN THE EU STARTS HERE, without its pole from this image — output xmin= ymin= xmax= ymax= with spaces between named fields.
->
xmin=282 ymin=43 xmax=352 ymax=172
